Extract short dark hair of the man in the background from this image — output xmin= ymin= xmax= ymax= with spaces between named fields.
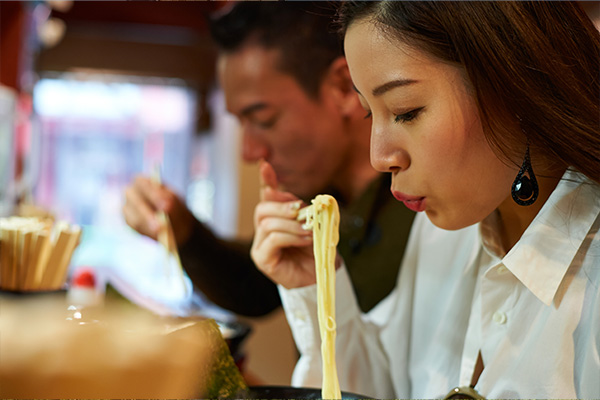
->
xmin=210 ymin=1 xmax=343 ymax=98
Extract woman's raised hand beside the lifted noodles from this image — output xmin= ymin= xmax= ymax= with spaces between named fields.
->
xmin=250 ymin=162 xmax=316 ymax=289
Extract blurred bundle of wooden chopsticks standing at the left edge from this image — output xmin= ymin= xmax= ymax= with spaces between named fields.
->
xmin=0 ymin=217 xmax=81 ymax=291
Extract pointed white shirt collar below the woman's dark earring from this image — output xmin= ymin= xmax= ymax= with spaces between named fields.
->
xmin=502 ymin=170 xmax=600 ymax=305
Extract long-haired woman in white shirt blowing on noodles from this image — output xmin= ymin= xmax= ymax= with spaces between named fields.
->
xmin=252 ymin=2 xmax=600 ymax=398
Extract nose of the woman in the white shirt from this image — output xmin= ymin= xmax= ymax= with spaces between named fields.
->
xmin=371 ymin=126 xmax=410 ymax=172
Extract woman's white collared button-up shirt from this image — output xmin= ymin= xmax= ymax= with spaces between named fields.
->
xmin=280 ymin=171 xmax=600 ymax=398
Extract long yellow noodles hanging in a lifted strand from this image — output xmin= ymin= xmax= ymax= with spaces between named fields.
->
xmin=298 ymin=195 xmax=342 ymax=399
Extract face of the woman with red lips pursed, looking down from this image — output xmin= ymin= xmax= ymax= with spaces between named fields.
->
xmin=345 ymin=20 xmax=518 ymax=230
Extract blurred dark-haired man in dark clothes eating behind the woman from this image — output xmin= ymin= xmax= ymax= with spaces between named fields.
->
xmin=123 ymin=2 xmax=414 ymax=316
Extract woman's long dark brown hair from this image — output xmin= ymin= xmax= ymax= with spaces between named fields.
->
xmin=337 ymin=1 xmax=600 ymax=183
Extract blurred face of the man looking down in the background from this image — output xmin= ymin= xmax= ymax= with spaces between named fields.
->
xmin=218 ymin=46 xmax=349 ymax=199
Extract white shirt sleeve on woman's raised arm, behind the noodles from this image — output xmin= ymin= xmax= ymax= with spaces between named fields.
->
xmin=279 ymin=266 xmax=394 ymax=398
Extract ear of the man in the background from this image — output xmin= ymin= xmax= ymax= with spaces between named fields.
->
xmin=324 ymin=56 xmax=361 ymax=117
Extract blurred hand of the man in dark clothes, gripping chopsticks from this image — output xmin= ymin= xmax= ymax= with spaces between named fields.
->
xmin=122 ymin=176 xmax=196 ymax=244
